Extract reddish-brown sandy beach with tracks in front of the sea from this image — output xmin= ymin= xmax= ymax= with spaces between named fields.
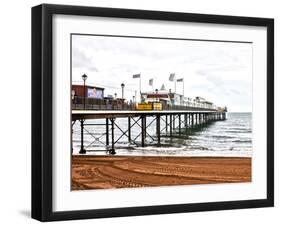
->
xmin=72 ymin=155 xmax=252 ymax=190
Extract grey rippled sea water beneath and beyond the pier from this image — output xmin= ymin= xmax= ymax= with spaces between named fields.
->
xmin=72 ymin=113 xmax=253 ymax=157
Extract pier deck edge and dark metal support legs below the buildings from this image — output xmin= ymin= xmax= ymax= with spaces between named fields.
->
xmin=72 ymin=110 xmax=226 ymax=154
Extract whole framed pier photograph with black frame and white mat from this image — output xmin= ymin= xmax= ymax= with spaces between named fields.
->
xmin=32 ymin=4 xmax=274 ymax=221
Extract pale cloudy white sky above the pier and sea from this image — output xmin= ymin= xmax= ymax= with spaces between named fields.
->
xmin=72 ymin=35 xmax=252 ymax=112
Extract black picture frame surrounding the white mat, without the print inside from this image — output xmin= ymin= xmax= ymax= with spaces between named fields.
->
xmin=32 ymin=4 xmax=274 ymax=221
